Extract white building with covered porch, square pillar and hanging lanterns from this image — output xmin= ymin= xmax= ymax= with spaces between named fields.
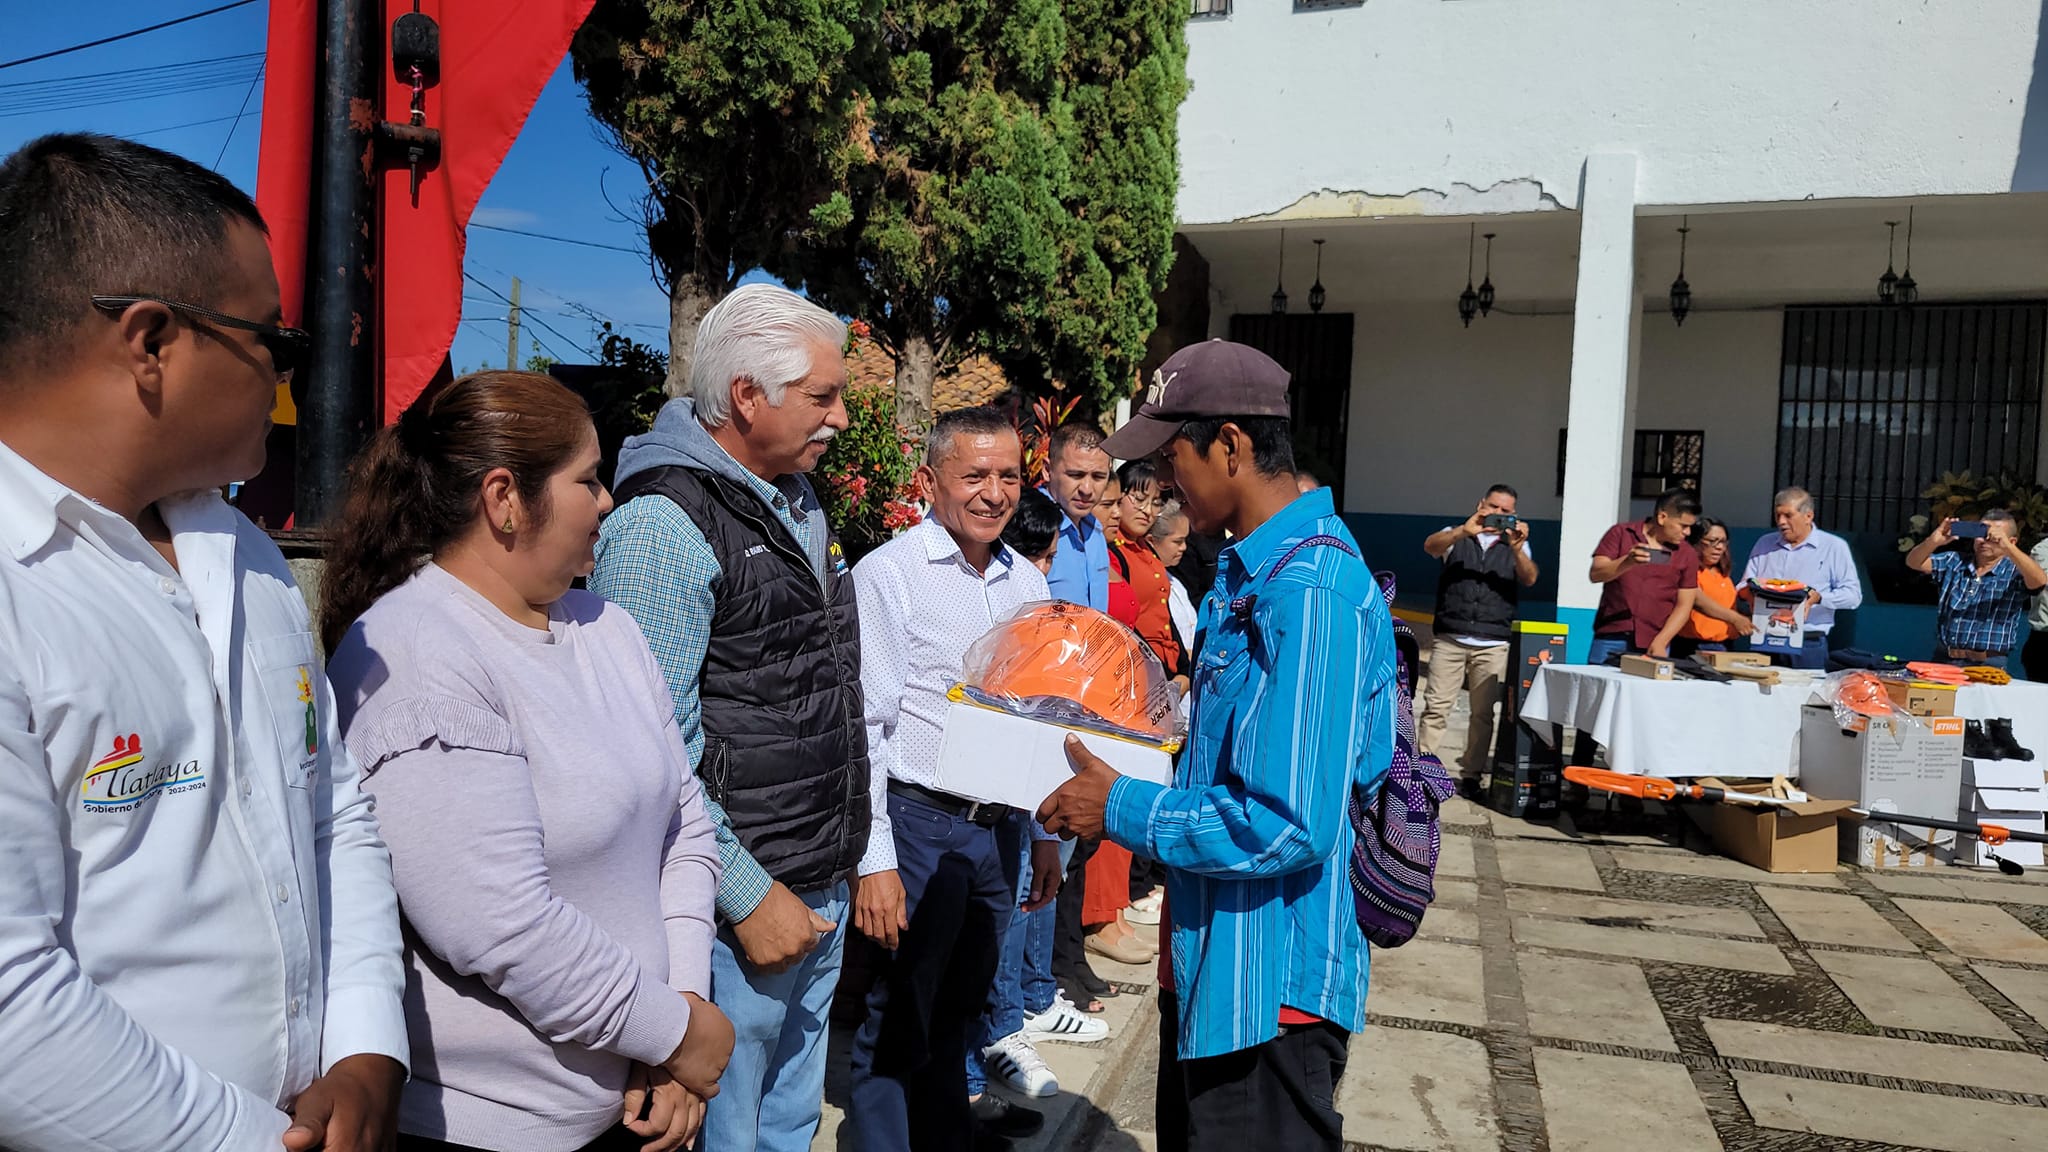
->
xmin=1163 ymin=0 xmax=2048 ymax=656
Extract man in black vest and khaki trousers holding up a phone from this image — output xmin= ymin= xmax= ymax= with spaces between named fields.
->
xmin=1417 ymin=484 xmax=1536 ymax=795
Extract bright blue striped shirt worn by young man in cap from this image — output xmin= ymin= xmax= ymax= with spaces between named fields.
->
xmin=1106 ymin=488 xmax=1397 ymax=1060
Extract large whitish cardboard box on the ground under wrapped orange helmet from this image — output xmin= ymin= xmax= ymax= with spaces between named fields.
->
xmin=1798 ymin=705 xmax=1962 ymax=820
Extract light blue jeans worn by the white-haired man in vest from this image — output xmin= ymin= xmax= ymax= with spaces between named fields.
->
xmin=698 ymin=883 xmax=850 ymax=1152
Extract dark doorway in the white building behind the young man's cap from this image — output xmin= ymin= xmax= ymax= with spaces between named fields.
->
xmin=1231 ymin=312 xmax=1352 ymax=500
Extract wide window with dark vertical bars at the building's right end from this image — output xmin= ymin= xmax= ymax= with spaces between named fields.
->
xmin=1776 ymin=301 xmax=2048 ymax=533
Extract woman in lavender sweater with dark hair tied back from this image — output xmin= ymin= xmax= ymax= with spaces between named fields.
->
xmin=322 ymin=373 xmax=733 ymax=1152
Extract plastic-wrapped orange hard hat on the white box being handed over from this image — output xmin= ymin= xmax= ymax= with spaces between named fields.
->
xmin=963 ymin=601 xmax=1178 ymax=740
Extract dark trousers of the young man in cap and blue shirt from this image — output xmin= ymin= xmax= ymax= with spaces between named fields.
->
xmin=1155 ymin=992 xmax=1352 ymax=1152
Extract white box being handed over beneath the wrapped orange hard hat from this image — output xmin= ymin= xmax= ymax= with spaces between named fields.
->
xmin=932 ymin=701 xmax=1174 ymax=812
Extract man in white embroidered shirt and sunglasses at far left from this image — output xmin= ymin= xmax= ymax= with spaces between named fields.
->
xmin=0 ymin=135 xmax=408 ymax=1152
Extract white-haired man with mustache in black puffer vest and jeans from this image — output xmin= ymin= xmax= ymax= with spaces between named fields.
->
xmin=590 ymin=285 xmax=870 ymax=1152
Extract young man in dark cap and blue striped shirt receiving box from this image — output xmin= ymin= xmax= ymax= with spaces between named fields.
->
xmin=1038 ymin=340 xmax=1395 ymax=1152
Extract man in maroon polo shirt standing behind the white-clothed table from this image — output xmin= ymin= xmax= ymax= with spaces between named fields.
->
xmin=1587 ymin=488 xmax=1700 ymax=664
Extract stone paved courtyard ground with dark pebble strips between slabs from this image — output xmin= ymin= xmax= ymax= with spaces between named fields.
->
xmin=819 ymin=684 xmax=2048 ymax=1152
